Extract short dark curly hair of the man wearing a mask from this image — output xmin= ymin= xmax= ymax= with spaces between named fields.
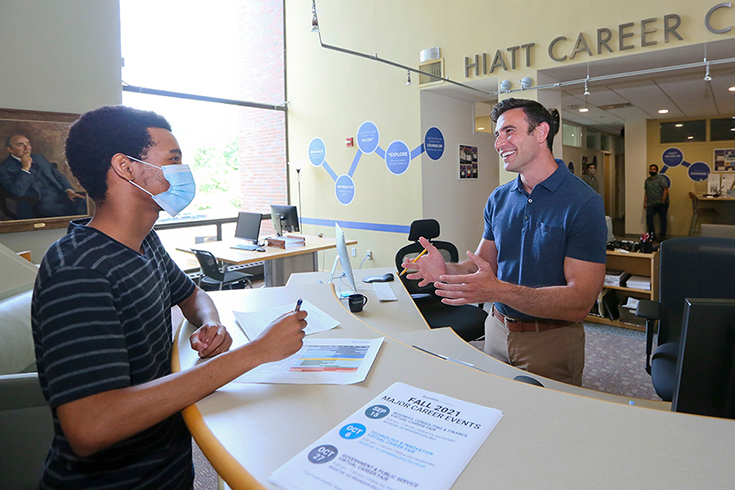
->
xmin=66 ymin=105 xmax=171 ymax=204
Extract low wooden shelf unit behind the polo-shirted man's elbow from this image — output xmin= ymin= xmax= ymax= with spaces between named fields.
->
xmin=585 ymin=250 xmax=659 ymax=331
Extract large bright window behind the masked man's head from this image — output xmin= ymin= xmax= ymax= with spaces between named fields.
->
xmin=120 ymin=0 xmax=288 ymax=220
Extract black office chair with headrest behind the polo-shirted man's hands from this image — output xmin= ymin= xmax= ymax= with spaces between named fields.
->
xmin=395 ymin=219 xmax=487 ymax=341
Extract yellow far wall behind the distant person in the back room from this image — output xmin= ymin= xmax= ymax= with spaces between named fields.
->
xmin=640 ymin=119 xmax=735 ymax=236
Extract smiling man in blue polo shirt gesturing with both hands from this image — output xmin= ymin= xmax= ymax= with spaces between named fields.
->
xmin=404 ymin=98 xmax=607 ymax=385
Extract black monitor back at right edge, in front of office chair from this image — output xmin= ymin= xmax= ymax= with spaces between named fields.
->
xmin=671 ymin=298 xmax=735 ymax=419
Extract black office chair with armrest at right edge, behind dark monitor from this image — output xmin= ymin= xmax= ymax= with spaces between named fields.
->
xmin=636 ymin=237 xmax=735 ymax=401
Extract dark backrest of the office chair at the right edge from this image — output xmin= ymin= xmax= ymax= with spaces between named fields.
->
xmin=658 ymin=237 xmax=735 ymax=345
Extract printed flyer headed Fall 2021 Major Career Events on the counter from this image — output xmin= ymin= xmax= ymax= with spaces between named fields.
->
xmin=270 ymin=383 xmax=503 ymax=490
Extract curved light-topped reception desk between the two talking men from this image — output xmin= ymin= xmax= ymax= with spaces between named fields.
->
xmin=173 ymin=271 xmax=735 ymax=489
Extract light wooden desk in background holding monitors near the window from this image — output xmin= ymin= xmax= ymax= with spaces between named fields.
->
xmin=181 ymin=235 xmax=357 ymax=287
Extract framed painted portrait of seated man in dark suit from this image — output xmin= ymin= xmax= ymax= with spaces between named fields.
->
xmin=0 ymin=109 xmax=90 ymax=233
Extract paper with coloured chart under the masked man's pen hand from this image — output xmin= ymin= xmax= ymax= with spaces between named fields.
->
xmin=234 ymin=337 xmax=385 ymax=385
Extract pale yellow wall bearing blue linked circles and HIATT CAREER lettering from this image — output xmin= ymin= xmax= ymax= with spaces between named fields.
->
xmin=285 ymin=0 xmax=735 ymax=266
